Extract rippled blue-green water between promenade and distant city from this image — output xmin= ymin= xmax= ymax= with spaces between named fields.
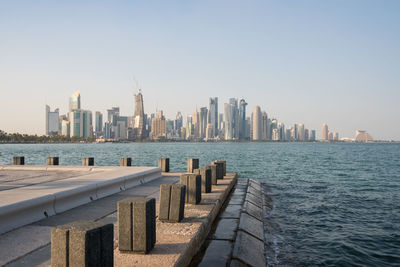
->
xmin=0 ymin=143 xmax=400 ymax=266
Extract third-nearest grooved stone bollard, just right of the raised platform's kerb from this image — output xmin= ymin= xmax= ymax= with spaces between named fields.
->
xmin=158 ymin=184 xmax=186 ymax=222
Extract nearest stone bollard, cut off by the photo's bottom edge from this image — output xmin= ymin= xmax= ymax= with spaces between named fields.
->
xmin=51 ymin=221 xmax=114 ymax=266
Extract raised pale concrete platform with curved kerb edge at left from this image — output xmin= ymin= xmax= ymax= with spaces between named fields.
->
xmin=0 ymin=166 xmax=161 ymax=234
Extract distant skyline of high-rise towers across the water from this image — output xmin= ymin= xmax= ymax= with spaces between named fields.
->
xmin=41 ymin=89 xmax=356 ymax=141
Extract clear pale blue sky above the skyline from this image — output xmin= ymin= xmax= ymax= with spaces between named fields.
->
xmin=0 ymin=0 xmax=400 ymax=140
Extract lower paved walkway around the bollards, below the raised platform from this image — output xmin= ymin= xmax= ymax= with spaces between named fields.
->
xmin=0 ymin=173 xmax=237 ymax=266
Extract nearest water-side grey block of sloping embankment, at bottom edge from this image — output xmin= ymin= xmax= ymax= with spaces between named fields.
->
xmin=232 ymin=230 xmax=266 ymax=266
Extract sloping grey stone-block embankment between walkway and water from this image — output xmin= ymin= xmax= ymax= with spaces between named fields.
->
xmin=190 ymin=179 xmax=267 ymax=267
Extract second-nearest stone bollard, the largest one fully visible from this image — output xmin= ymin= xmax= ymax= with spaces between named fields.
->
xmin=118 ymin=197 xmax=156 ymax=254
